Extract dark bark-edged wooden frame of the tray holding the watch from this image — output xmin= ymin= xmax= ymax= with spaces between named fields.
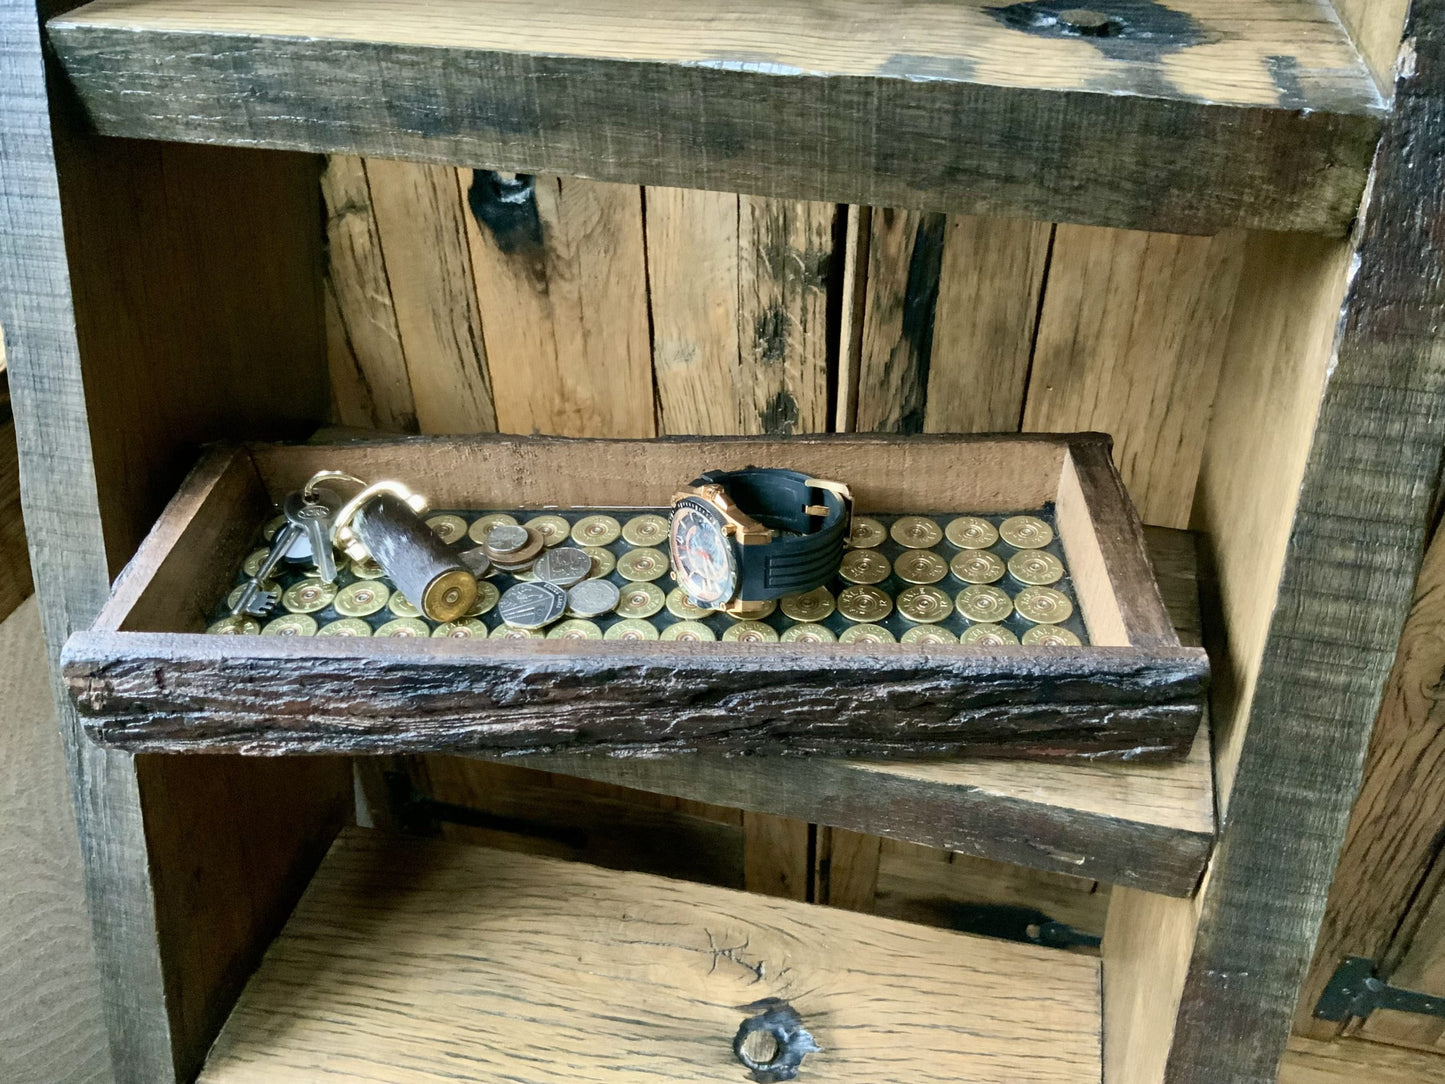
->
xmin=64 ymin=434 xmax=1208 ymax=760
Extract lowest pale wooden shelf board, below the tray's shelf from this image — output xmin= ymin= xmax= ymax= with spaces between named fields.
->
xmin=199 ymin=830 xmax=1101 ymax=1084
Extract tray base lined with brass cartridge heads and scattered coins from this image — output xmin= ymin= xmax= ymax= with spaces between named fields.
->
xmin=210 ymin=509 xmax=1085 ymax=646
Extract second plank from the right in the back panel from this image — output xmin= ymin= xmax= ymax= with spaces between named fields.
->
xmin=923 ymin=215 xmax=1051 ymax=436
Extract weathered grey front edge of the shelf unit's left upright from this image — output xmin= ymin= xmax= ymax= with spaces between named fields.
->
xmin=0 ymin=0 xmax=165 ymax=1084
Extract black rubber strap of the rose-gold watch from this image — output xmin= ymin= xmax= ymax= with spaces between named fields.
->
xmin=692 ymin=467 xmax=853 ymax=601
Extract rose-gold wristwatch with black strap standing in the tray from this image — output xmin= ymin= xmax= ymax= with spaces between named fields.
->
xmin=670 ymin=467 xmax=853 ymax=617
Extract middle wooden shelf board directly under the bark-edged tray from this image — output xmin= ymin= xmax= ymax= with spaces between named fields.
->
xmin=525 ymin=528 xmax=1215 ymax=896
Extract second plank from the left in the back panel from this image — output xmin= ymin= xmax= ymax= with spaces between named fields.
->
xmin=366 ymin=159 xmax=497 ymax=432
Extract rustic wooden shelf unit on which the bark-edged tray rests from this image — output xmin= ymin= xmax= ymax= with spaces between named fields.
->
xmin=0 ymin=0 xmax=1445 ymax=1084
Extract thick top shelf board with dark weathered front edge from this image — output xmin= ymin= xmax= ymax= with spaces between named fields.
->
xmin=49 ymin=0 xmax=1383 ymax=233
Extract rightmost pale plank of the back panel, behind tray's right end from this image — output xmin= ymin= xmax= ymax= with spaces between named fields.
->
xmin=1028 ymin=225 xmax=1244 ymax=528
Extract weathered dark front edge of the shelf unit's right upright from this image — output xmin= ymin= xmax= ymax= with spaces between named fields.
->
xmin=1168 ymin=0 xmax=1445 ymax=1084
